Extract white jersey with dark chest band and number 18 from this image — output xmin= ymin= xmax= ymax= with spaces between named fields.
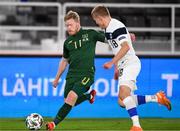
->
xmin=105 ymin=18 xmax=138 ymax=68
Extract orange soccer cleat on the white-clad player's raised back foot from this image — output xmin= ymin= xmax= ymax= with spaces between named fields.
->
xmin=156 ymin=91 xmax=171 ymax=111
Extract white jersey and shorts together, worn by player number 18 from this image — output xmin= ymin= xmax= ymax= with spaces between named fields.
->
xmin=105 ymin=19 xmax=141 ymax=91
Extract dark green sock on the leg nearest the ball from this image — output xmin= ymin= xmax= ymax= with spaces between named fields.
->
xmin=54 ymin=103 xmax=72 ymax=125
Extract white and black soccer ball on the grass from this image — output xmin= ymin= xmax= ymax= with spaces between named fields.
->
xmin=26 ymin=113 xmax=43 ymax=130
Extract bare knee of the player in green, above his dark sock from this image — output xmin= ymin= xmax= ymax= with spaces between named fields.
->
xmin=65 ymin=91 xmax=78 ymax=106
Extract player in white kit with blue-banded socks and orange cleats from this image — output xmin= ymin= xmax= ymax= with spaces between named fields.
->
xmin=91 ymin=5 xmax=171 ymax=131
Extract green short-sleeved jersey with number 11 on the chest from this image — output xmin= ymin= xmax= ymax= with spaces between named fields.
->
xmin=63 ymin=29 xmax=105 ymax=78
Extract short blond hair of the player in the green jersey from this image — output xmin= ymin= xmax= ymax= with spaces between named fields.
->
xmin=64 ymin=10 xmax=80 ymax=22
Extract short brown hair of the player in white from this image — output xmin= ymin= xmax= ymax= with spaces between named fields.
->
xmin=91 ymin=5 xmax=110 ymax=17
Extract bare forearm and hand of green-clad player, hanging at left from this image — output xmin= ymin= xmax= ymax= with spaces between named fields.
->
xmin=52 ymin=58 xmax=68 ymax=88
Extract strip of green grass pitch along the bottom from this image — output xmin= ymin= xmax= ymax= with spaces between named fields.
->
xmin=0 ymin=118 xmax=180 ymax=131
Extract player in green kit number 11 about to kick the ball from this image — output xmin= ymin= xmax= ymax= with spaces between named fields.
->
xmin=46 ymin=11 xmax=105 ymax=131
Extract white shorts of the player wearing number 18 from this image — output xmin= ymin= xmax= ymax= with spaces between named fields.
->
xmin=118 ymin=59 xmax=141 ymax=91
